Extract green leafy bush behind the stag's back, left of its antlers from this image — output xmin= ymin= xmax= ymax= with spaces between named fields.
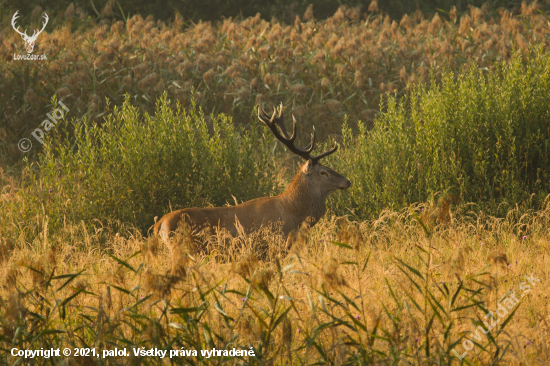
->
xmin=21 ymin=96 xmax=276 ymax=230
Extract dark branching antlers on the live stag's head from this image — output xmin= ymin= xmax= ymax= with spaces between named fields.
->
xmin=258 ymin=103 xmax=338 ymax=164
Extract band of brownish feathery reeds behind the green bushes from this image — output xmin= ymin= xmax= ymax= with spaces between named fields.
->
xmin=0 ymin=2 xmax=550 ymax=161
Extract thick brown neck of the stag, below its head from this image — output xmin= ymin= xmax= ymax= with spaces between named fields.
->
xmin=281 ymin=172 xmax=326 ymax=223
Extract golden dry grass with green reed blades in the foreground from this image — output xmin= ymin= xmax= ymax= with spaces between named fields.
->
xmin=0 ymin=199 xmax=550 ymax=365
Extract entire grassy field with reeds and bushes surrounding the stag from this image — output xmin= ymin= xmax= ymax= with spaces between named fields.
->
xmin=0 ymin=2 xmax=550 ymax=366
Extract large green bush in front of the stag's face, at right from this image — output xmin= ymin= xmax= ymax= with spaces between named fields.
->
xmin=332 ymin=50 xmax=550 ymax=217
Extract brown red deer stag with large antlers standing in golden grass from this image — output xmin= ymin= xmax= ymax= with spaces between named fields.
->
xmin=154 ymin=104 xmax=351 ymax=241
